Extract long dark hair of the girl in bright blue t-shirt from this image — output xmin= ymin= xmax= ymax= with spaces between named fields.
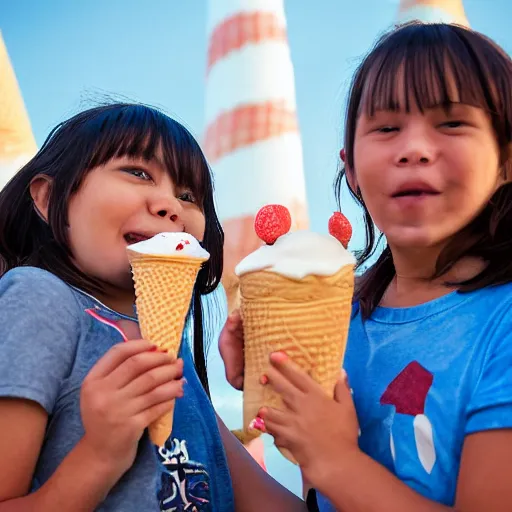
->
xmin=335 ymin=22 xmax=512 ymax=318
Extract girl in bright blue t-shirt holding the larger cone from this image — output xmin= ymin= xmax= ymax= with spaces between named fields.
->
xmin=220 ymin=23 xmax=512 ymax=512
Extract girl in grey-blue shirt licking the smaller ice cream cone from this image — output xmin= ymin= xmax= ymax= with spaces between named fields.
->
xmin=0 ymin=104 xmax=305 ymax=512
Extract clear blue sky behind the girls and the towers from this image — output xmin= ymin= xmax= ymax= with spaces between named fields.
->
xmin=4 ymin=0 xmax=512 ymax=492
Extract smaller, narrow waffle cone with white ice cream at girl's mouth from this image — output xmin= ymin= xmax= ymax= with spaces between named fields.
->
xmin=128 ymin=233 xmax=210 ymax=446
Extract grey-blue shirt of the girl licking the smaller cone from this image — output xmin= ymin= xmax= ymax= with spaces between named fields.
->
xmin=0 ymin=267 xmax=234 ymax=512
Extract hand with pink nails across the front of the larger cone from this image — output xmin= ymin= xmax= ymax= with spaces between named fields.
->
xmin=260 ymin=352 xmax=359 ymax=486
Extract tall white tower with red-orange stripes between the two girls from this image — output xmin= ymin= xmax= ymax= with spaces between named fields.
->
xmin=204 ymin=0 xmax=308 ymax=310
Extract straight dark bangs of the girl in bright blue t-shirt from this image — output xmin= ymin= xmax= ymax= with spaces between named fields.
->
xmin=361 ymin=25 xmax=497 ymax=116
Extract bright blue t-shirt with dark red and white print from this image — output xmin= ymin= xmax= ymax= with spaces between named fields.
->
xmin=318 ymin=284 xmax=512 ymax=512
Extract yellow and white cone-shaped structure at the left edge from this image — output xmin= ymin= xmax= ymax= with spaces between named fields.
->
xmin=0 ymin=33 xmax=37 ymax=189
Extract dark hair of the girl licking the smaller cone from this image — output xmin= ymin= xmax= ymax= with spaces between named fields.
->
xmin=0 ymin=103 xmax=224 ymax=392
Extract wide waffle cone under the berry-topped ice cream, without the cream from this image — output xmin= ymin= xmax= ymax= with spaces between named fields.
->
xmin=240 ymin=265 xmax=354 ymax=463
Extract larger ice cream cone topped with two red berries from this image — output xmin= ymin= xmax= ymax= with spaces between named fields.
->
xmin=236 ymin=205 xmax=355 ymax=462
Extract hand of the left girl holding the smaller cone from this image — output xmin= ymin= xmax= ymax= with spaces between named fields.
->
xmin=80 ymin=324 xmax=183 ymax=474
